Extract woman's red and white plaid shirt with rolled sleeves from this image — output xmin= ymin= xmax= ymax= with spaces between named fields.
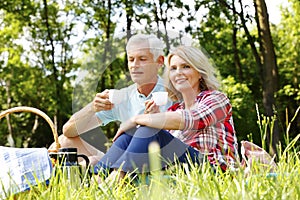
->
xmin=168 ymin=90 xmax=239 ymax=170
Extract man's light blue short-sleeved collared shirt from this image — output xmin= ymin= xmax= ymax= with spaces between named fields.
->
xmin=96 ymin=77 xmax=172 ymax=126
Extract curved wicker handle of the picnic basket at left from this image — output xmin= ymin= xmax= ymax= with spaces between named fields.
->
xmin=0 ymin=106 xmax=60 ymax=151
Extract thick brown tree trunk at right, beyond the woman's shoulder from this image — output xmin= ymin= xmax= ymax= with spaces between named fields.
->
xmin=254 ymin=0 xmax=279 ymax=153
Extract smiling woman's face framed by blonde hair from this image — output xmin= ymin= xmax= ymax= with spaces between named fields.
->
xmin=169 ymin=55 xmax=201 ymax=94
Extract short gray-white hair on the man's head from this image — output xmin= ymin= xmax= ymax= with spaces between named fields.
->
xmin=126 ymin=34 xmax=164 ymax=60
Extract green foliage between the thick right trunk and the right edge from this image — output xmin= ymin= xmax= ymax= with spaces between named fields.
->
xmin=272 ymin=0 xmax=300 ymax=141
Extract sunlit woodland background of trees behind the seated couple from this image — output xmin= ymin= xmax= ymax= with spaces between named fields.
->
xmin=0 ymin=0 xmax=300 ymax=156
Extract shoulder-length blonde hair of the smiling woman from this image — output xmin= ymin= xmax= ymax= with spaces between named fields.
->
xmin=164 ymin=46 xmax=220 ymax=101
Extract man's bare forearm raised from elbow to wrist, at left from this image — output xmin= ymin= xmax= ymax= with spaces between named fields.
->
xmin=63 ymin=102 xmax=101 ymax=137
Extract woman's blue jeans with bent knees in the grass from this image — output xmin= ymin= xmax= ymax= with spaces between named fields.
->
xmin=94 ymin=126 xmax=203 ymax=173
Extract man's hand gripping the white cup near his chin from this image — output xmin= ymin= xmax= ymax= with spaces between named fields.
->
xmin=93 ymin=90 xmax=114 ymax=112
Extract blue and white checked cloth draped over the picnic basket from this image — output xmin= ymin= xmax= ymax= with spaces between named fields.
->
xmin=0 ymin=146 xmax=52 ymax=199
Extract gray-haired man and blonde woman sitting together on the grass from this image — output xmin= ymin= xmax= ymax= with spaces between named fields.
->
xmin=50 ymin=35 xmax=239 ymax=181
